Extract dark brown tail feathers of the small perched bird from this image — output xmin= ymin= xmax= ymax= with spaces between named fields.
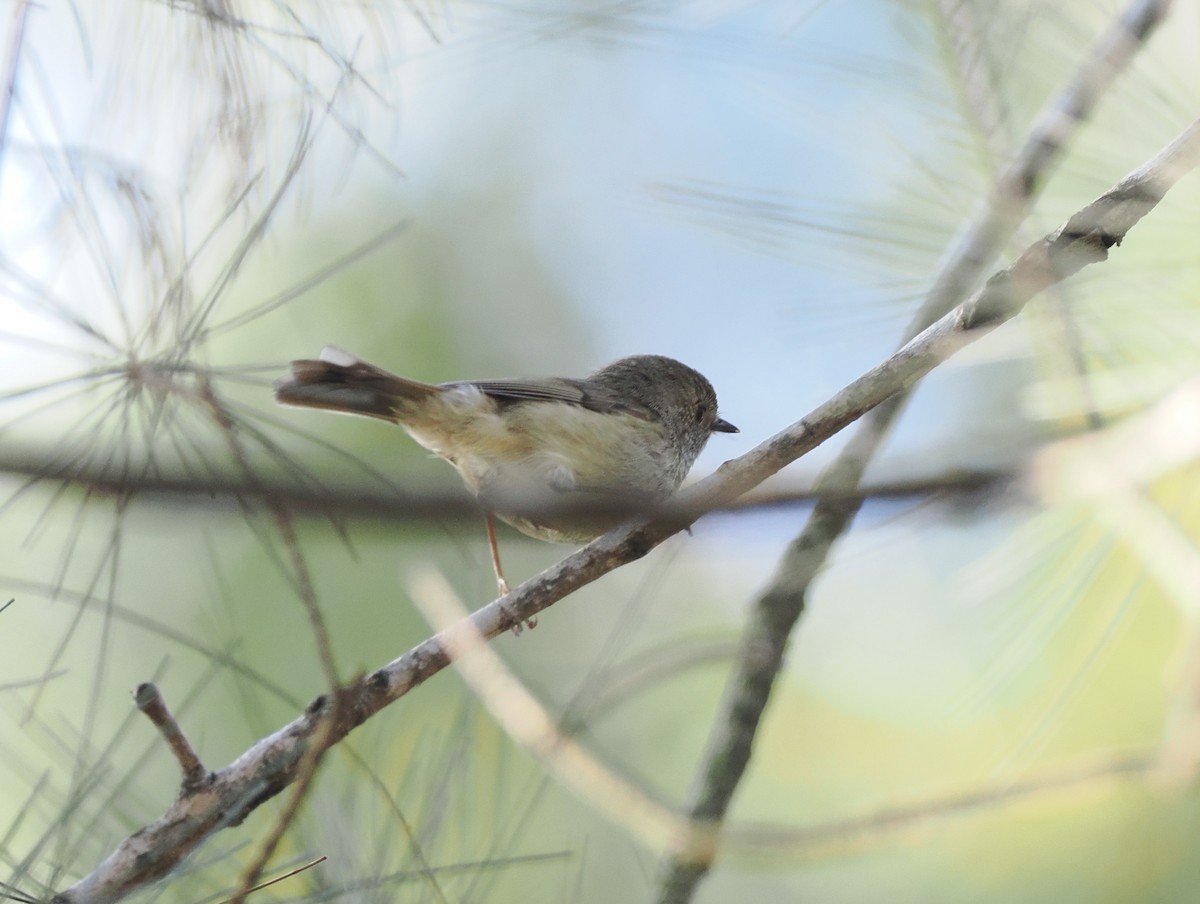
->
xmin=275 ymin=346 xmax=442 ymax=420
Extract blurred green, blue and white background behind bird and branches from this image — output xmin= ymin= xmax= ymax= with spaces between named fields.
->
xmin=0 ymin=0 xmax=1200 ymax=903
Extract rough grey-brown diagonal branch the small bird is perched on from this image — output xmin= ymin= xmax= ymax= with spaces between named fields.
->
xmin=52 ymin=122 xmax=1200 ymax=904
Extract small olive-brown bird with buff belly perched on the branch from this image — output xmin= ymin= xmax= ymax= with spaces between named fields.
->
xmin=275 ymin=347 xmax=738 ymax=595
